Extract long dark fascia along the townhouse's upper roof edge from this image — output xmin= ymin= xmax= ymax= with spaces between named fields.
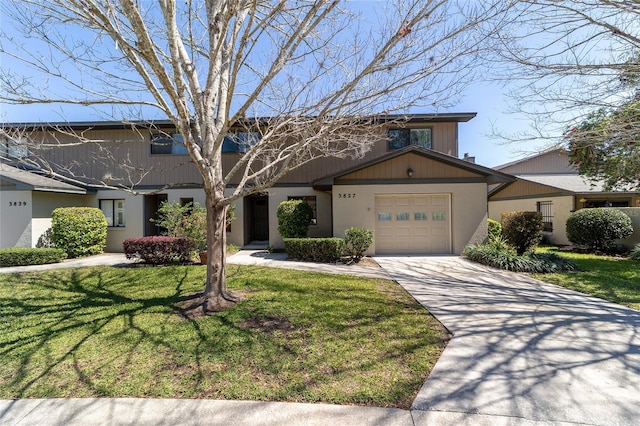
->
xmin=2 ymin=112 xmax=477 ymax=130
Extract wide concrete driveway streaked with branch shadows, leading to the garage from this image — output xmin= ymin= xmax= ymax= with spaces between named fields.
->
xmin=375 ymin=256 xmax=640 ymax=425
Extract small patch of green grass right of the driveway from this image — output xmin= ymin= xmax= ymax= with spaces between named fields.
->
xmin=534 ymin=248 xmax=640 ymax=310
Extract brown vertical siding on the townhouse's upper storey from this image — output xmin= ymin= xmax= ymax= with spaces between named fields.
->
xmin=32 ymin=122 xmax=458 ymax=187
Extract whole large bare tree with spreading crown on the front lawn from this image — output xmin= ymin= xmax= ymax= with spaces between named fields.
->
xmin=0 ymin=0 xmax=502 ymax=309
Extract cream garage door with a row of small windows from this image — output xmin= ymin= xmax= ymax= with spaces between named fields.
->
xmin=375 ymin=194 xmax=451 ymax=254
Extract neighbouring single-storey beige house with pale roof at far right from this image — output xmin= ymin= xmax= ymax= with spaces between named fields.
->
xmin=489 ymin=149 xmax=640 ymax=245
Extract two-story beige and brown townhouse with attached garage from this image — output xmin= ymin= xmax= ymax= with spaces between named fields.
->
xmin=0 ymin=113 xmax=512 ymax=254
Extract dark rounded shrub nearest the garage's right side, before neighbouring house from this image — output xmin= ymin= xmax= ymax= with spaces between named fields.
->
xmin=502 ymin=212 xmax=544 ymax=255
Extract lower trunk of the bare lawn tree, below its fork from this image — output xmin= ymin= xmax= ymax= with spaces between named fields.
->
xmin=203 ymin=191 xmax=239 ymax=312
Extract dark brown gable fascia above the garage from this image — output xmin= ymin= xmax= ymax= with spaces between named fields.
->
xmin=312 ymin=146 xmax=516 ymax=189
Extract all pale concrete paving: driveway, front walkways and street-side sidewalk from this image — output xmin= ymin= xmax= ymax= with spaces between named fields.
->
xmin=0 ymin=251 xmax=640 ymax=426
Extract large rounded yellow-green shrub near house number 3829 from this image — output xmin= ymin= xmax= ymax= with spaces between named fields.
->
xmin=51 ymin=207 xmax=107 ymax=257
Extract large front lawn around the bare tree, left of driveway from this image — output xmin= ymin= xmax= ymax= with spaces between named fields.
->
xmin=0 ymin=266 xmax=447 ymax=408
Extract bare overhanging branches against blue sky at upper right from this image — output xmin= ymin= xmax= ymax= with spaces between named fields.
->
xmin=494 ymin=0 xmax=640 ymax=153
